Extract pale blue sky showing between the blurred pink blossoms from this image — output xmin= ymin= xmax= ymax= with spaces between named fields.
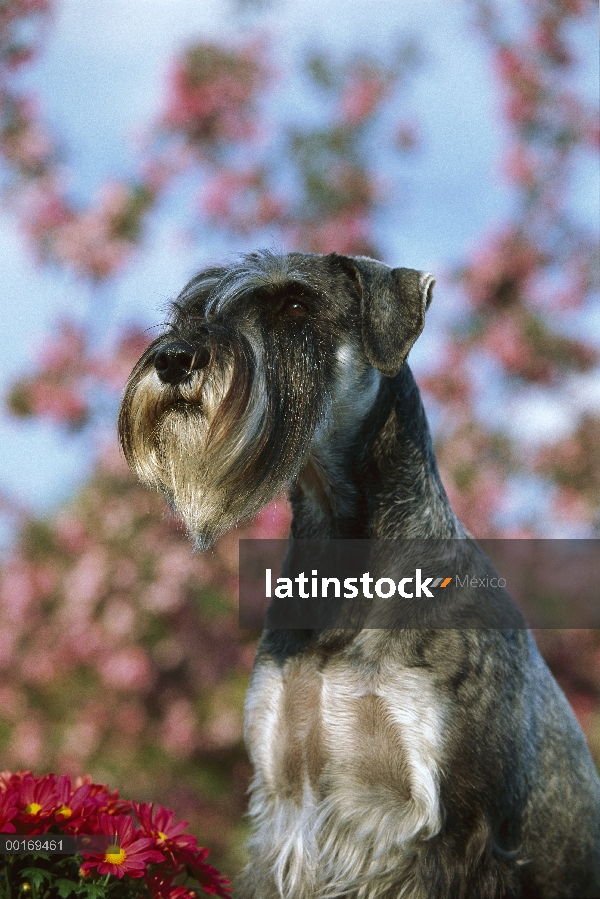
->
xmin=0 ymin=0 xmax=600 ymax=536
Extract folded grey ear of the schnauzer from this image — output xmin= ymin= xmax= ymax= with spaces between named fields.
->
xmin=340 ymin=256 xmax=435 ymax=377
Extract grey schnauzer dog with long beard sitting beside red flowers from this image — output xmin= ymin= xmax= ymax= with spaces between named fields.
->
xmin=119 ymin=252 xmax=600 ymax=899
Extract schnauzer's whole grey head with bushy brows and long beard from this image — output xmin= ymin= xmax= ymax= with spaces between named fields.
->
xmin=119 ymin=252 xmax=433 ymax=548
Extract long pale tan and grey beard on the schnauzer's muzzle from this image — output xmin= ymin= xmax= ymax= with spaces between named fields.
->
xmin=119 ymin=341 xmax=322 ymax=549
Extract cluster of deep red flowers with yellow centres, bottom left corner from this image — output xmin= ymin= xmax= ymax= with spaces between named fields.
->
xmin=0 ymin=771 xmax=231 ymax=899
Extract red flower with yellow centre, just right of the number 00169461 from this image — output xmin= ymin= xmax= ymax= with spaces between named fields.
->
xmin=81 ymin=814 xmax=164 ymax=879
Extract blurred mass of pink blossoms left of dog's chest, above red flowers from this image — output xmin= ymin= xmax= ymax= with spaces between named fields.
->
xmin=0 ymin=447 xmax=289 ymax=771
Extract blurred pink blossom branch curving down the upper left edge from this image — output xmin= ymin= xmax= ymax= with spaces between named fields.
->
xmin=0 ymin=0 xmax=162 ymax=281
